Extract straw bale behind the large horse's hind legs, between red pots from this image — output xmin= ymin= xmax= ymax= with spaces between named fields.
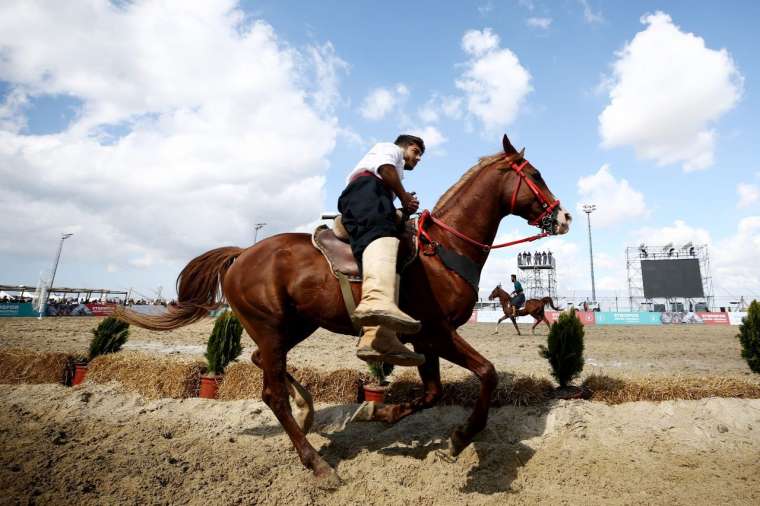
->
xmin=218 ymin=363 xmax=362 ymax=403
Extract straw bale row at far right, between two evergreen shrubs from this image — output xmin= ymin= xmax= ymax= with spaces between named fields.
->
xmin=583 ymin=374 xmax=760 ymax=404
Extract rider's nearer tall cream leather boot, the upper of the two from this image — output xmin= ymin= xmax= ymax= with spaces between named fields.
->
xmin=354 ymin=237 xmax=421 ymax=336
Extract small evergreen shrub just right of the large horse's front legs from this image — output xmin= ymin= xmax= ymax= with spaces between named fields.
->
xmin=539 ymin=309 xmax=584 ymax=388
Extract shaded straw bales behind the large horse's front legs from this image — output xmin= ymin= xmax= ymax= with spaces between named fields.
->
xmin=386 ymin=371 xmax=554 ymax=407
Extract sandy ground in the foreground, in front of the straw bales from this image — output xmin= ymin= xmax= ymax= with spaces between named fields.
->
xmin=0 ymin=384 xmax=760 ymax=506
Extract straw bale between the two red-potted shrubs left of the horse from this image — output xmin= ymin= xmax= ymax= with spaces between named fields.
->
xmin=87 ymin=352 xmax=205 ymax=399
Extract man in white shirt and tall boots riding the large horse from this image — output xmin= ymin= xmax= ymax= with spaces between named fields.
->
xmin=338 ymin=135 xmax=425 ymax=366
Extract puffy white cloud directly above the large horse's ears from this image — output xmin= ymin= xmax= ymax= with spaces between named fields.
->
xmin=456 ymin=28 xmax=533 ymax=131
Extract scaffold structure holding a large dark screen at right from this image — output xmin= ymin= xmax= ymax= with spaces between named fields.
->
xmin=625 ymin=242 xmax=716 ymax=312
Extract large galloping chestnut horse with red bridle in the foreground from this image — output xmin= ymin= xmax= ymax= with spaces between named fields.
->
xmin=117 ymin=135 xmax=572 ymax=487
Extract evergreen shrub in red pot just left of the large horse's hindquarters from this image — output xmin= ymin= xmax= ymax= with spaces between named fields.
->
xmin=198 ymin=311 xmax=243 ymax=399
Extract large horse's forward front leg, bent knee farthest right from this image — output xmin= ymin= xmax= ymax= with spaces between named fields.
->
xmin=439 ymin=330 xmax=499 ymax=456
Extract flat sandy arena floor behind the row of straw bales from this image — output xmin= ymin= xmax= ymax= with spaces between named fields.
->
xmin=0 ymin=317 xmax=751 ymax=377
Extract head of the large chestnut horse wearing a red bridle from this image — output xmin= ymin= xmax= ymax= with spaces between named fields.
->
xmin=498 ymin=134 xmax=573 ymax=235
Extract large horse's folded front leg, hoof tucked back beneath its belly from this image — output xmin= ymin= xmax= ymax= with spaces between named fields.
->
xmin=352 ymin=354 xmax=443 ymax=423
